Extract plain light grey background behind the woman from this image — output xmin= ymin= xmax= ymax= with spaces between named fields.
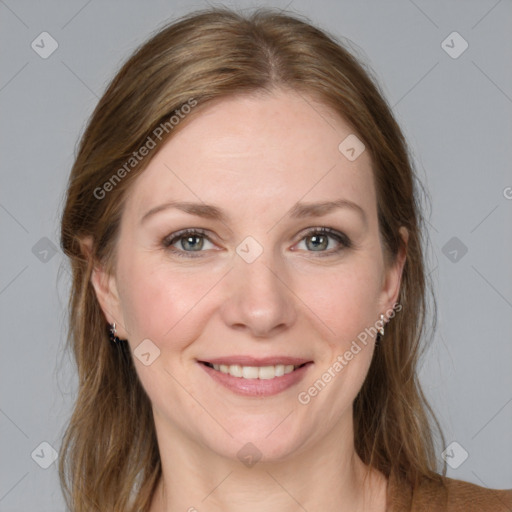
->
xmin=0 ymin=0 xmax=512 ymax=512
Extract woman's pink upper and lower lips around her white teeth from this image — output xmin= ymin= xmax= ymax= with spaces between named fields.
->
xmin=197 ymin=357 xmax=313 ymax=397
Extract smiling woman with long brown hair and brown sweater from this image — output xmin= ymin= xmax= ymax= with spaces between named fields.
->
xmin=60 ymin=9 xmax=512 ymax=512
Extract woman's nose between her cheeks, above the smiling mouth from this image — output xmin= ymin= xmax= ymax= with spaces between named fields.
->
xmin=221 ymin=256 xmax=297 ymax=338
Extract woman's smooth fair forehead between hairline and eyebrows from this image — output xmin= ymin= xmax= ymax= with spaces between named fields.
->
xmin=122 ymin=91 xmax=376 ymax=226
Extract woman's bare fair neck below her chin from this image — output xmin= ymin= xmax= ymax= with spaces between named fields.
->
xmin=150 ymin=410 xmax=387 ymax=512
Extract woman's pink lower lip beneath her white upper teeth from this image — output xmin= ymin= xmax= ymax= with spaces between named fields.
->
xmin=198 ymin=363 xmax=312 ymax=397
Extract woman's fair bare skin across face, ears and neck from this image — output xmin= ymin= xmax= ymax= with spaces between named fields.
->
xmin=92 ymin=90 xmax=407 ymax=512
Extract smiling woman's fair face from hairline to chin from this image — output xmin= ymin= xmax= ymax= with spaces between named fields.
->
xmin=93 ymin=91 xmax=403 ymax=460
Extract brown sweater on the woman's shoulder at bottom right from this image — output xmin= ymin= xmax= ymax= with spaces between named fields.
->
xmin=386 ymin=476 xmax=512 ymax=512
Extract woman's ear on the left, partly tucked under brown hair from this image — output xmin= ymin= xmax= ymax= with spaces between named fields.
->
xmin=81 ymin=239 xmax=127 ymax=339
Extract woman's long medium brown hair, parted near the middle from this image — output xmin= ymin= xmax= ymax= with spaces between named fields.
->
xmin=59 ymin=9 xmax=446 ymax=512
